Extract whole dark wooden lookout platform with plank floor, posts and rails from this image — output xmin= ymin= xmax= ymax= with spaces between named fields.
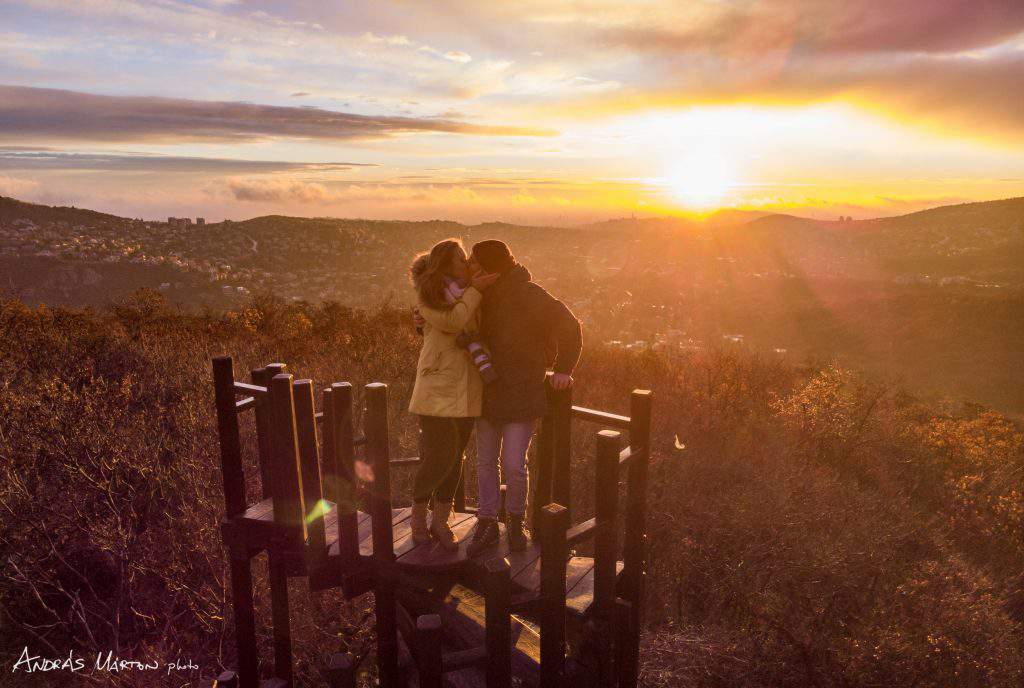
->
xmin=213 ymin=357 xmax=651 ymax=688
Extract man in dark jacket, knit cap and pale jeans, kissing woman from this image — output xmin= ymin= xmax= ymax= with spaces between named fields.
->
xmin=468 ymin=241 xmax=583 ymax=556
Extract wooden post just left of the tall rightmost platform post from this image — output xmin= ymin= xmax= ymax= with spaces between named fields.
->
xmin=594 ymin=430 xmax=621 ymax=624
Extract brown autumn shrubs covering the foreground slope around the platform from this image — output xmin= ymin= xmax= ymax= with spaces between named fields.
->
xmin=0 ymin=292 xmax=1024 ymax=686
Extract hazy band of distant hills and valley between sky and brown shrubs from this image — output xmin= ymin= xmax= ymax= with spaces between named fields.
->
xmin=0 ymin=192 xmax=1024 ymax=413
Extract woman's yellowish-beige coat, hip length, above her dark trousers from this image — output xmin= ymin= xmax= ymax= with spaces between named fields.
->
xmin=409 ymin=287 xmax=483 ymax=418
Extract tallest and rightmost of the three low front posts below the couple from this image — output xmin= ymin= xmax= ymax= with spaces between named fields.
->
xmin=540 ymin=504 xmax=569 ymax=688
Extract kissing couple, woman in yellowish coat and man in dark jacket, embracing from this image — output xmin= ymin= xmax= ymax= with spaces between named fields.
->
xmin=409 ymin=239 xmax=583 ymax=557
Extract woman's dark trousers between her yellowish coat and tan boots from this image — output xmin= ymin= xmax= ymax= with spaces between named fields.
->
xmin=413 ymin=416 xmax=476 ymax=504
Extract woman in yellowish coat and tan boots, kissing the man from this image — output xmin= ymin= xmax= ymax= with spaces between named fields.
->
xmin=409 ymin=239 xmax=498 ymax=549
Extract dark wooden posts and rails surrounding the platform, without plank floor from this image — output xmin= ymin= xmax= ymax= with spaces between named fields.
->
xmin=213 ymin=357 xmax=651 ymax=688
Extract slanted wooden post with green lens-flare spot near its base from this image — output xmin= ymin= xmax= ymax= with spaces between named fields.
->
xmin=292 ymin=380 xmax=327 ymax=563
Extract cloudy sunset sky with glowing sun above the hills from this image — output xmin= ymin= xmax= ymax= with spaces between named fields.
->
xmin=0 ymin=0 xmax=1024 ymax=224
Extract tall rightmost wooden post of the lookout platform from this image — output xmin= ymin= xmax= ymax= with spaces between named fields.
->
xmin=620 ymin=389 xmax=652 ymax=685
